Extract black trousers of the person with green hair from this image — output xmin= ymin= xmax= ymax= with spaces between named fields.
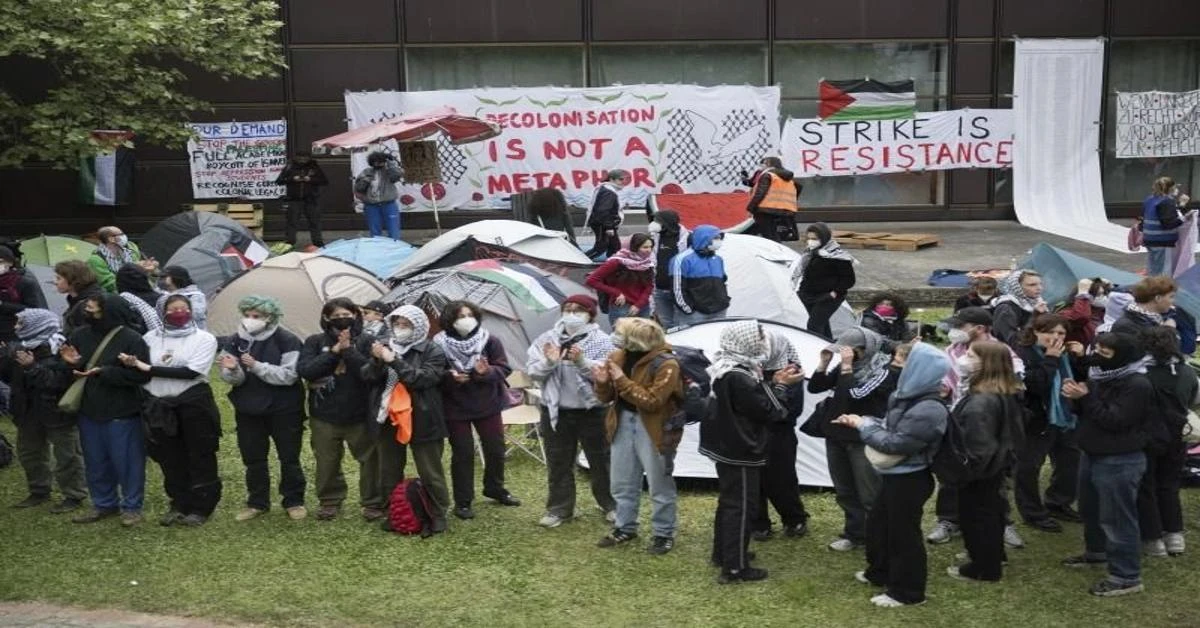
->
xmin=236 ymin=411 xmax=306 ymax=510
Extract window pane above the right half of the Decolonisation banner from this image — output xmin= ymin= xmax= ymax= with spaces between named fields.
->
xmin=590 ymin=43 xmax=767 ymax=86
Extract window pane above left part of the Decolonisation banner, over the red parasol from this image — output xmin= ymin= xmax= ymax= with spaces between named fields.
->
xmin=404 ymin=46 xmax=583 ymax=91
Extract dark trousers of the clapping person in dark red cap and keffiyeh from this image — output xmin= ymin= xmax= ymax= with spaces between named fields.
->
xmin=541 ymin=407 xmax=617 ymax=519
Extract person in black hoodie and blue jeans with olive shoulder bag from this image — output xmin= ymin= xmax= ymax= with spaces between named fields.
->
xmin=60 ymin=294 xmax=150 ymax=527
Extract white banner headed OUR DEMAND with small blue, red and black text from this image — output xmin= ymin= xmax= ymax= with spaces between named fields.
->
xmin=187 ymin=120 xmax=288 ymax=199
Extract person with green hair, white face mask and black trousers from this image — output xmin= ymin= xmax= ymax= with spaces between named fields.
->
xmin=217 ymin=295 xmax=308 ymax=521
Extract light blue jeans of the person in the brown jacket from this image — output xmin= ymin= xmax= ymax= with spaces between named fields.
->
xmin=610 ymin=411 xmax=678 ymax=538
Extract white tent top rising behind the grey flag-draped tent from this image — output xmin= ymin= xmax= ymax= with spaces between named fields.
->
xmin=390 ymin=220 xmax=592 ymax=281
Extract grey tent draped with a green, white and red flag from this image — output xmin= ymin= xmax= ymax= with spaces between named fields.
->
xmin=383 ymin=259 xmax=594 ymax=370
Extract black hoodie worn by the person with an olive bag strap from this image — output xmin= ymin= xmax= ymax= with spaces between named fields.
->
xmin=71 ymin=294 xmax=150 ymax=420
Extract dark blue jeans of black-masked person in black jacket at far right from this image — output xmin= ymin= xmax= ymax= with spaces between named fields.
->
xmin=1079 ymin=451 xmax=1146 ymax=585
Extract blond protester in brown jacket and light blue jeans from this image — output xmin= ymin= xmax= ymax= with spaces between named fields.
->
xmin=592 ymin=319 xmax=681 ymax=555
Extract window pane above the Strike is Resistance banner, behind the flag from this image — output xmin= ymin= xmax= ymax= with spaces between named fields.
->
xmin=775 ymin=42 xmax=946 ymax=98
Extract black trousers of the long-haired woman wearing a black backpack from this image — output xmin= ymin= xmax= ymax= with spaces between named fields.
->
xmin=958 ymin=473 xmax=1006 ymax=580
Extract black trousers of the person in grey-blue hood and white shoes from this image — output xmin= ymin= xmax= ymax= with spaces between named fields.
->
xmin=866 ymin=469 xmax=934 ymax=604
